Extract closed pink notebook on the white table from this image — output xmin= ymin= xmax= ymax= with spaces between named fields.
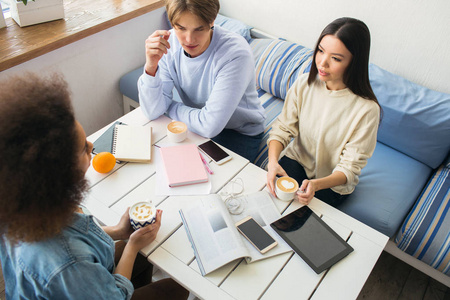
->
xmin=159 ymin=144 xmax=208 ymax=187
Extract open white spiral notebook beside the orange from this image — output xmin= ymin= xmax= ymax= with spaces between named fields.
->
xmin=111 ymin=124 xmax=152 ymax=162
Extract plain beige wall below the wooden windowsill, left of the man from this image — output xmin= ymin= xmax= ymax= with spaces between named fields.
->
xmin=0 ymin=8 xmax=167 ymax=135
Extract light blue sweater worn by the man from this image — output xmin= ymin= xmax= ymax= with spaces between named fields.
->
xmin=138 ymin=26 xmax=265 ymax=138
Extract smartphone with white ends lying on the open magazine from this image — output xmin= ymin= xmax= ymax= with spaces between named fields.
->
xmin=236 ymin=216 xmax=278 ymax=254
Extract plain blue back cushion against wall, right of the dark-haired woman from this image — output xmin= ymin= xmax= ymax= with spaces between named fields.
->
xmin=369 ymin=64 xmax=450 ymax=169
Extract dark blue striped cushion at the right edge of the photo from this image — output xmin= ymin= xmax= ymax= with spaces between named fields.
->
xmin=396 ymin=159 xmax=450 ymax=276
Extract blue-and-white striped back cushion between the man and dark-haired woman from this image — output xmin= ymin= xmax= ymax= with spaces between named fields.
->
xmin=250 ymin=39 xmax=313 ymax=99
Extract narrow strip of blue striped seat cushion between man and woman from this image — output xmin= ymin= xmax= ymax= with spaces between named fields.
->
xmin=254 ymin=88 xmax=284 ymax=169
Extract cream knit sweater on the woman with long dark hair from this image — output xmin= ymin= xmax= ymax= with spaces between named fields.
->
xmin=268 ymin=74 xmax=380 ymax=194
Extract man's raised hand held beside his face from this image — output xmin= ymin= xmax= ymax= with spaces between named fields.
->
xmin=145 ymin=30 xmax=170 ymax=76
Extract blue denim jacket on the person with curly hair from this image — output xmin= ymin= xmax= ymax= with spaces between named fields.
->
xmin=0 ymin=213 xmax=134 ymax=299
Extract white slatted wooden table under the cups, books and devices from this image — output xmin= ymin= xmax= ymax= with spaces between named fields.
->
xmin=84 ymin=108 xmax=388 ymax=300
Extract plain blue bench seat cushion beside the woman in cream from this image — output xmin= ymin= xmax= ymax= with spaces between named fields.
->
xmin=338 ymin=142 xmax=432 ymax=237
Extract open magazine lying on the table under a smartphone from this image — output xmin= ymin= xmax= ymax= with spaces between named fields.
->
xmin=180 ymin=191 xmax=292 ymax=276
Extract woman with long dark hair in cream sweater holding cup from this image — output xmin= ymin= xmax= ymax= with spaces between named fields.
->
xmin=267 ymin=18 xmax=380 ymax=206
